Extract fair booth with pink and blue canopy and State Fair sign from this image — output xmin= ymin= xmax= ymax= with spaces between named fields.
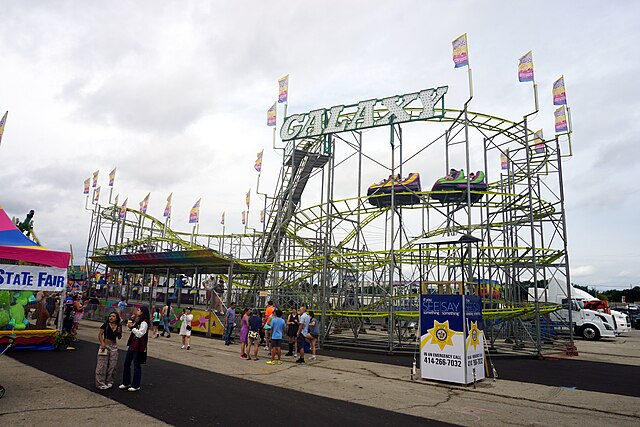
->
xmin=0 ymin=208 xmax=70 ymax=350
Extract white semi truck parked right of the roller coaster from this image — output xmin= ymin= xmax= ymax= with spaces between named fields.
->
xmin=528 ymin=280 xmax=617 ymax=340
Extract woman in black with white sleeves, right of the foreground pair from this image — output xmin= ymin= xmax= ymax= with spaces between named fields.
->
xmin=118 ymin=306 xmax=149 ymax=391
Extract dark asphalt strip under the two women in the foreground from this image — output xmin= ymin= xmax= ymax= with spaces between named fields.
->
xmin=11 ymin=341 xmax=454 ymax=427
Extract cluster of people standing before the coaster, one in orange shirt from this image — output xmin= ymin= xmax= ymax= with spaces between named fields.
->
xmin=240 ymin=301 xmax=320 ymax=365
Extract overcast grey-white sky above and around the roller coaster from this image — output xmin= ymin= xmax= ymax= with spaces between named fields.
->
xmin=0 ymin=0 xmax=640 ymax=287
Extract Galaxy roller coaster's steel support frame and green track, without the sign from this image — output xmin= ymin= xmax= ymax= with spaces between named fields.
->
xmin=87 ymin=93 xmax=572 ymax=355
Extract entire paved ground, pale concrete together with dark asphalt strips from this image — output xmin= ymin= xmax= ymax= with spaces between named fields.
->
xmin=6 ymin=322 xmax=640 ymax=427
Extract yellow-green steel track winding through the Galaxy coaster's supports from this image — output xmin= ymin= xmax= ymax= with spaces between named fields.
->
xmin=95 ymin=109 xmax=563 ymax=319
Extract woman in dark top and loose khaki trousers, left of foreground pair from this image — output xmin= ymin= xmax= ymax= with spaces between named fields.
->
xmin=96 ymin=311 xmax=122 ymax=390
